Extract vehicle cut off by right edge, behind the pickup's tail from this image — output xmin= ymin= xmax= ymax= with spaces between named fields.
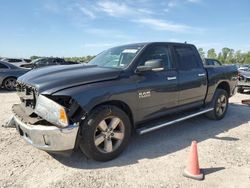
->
xmin=238 ymin=67 xmax=250 ymax=93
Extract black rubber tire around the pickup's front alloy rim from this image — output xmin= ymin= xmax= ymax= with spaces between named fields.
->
xmin=79 ymin=105 xmax=131 ymax=161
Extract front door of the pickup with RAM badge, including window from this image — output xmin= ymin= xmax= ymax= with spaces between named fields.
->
xmin=137 ymin=44 xmax=178 ymax=120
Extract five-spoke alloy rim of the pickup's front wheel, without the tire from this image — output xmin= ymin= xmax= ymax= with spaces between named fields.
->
xmin=94 ymin=117 xmax=125 ymax=153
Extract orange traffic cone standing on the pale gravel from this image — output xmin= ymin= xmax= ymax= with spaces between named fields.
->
xmin=183 ymin=141 xmax=204 ymax=180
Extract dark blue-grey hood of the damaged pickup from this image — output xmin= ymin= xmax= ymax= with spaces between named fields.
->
xmin=18 ymin=64 xmax=121 ymax=94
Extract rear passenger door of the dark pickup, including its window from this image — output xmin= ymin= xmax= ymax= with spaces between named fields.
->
xmin=173 ymin=45 xmax=207 ymax=105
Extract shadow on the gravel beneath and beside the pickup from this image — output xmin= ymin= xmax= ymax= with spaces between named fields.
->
xmin=53 ymin=104 xmax=250 ymax=169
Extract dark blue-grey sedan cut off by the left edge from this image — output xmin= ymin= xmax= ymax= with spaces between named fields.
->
xmin=0 ymin=61 xmax=29 ymax=90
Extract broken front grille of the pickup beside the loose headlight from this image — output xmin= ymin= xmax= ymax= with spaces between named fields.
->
xmin=16 ymin=82 xmax=37 ymax=111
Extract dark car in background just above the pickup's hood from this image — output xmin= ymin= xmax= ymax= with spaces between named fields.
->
xmin=21 ymin=57 xmax=78 ymax=69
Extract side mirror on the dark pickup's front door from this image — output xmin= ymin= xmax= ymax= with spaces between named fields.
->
xmin=137 ymin=59 xmax=164 ymax=72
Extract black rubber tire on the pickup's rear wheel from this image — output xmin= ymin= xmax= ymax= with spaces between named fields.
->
xmin=206 ymin=89 xmax=228 ymax=120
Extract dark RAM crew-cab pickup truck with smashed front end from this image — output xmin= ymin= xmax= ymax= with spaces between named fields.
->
xmin=9 ymin=42 xmax=237 ymax=161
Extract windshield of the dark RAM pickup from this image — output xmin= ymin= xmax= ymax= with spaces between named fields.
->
xmin=88 ymin=44 xmax=144 ymax=68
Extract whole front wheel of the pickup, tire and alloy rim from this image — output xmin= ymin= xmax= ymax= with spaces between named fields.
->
xmin=80 ymin=105 xmax=131 ymax=161
